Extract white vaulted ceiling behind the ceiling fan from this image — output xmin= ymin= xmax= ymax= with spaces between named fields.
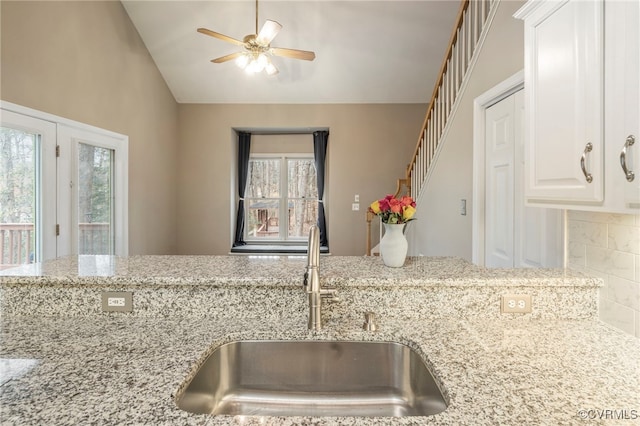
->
xmin=122 ymin=0 xmax=460 ymax=104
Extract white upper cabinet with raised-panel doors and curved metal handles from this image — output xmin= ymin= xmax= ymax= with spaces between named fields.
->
xmin=515 ymin=0 xmax=640 ymax=213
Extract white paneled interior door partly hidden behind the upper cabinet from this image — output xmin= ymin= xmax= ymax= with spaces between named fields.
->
xmin=485 ymin=90 xmax=563 ymax=268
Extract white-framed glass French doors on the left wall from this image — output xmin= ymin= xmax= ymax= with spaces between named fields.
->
xmin=0 ymin=102 xmax=128 ymax=268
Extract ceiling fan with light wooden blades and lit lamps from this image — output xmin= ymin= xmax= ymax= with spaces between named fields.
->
xmin=198 ymin=0 xmax=316 ymax=75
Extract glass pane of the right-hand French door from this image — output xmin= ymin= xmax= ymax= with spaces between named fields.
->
xmin=77 ymin=142 xmax=115 ymax=255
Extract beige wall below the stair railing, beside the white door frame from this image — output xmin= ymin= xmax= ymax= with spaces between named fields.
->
xmin=410 ymin=1 xmax=524 ymax=260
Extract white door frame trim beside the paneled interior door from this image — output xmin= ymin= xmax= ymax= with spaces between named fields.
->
xmin=471 ymin=70 xmax=524 ymax=266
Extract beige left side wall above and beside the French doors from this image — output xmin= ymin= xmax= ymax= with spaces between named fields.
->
xmin=0 ymin=1 xmax=178 ymax=254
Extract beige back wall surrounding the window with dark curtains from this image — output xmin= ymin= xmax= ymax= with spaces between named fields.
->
xmin=178 ymin=104 xmax=426 ymax=255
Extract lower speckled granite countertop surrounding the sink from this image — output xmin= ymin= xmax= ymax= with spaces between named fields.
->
xmin=0 ymin=317 xmax=640 ymax=426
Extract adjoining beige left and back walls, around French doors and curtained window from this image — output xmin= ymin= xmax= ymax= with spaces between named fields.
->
xmin=0 ymin=1 xmax=426 ymax=255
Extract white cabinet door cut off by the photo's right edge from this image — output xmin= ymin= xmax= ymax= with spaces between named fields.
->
xmin=605 ymin=0 xmax=640 ymax=208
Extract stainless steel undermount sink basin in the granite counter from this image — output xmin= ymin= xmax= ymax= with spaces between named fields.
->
xmin=178 ymin=341 xmax=447 ymax=417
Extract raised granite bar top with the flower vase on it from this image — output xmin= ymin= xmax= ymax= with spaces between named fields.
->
xmin=0 ymin=256 xmax=600 ymax=287
